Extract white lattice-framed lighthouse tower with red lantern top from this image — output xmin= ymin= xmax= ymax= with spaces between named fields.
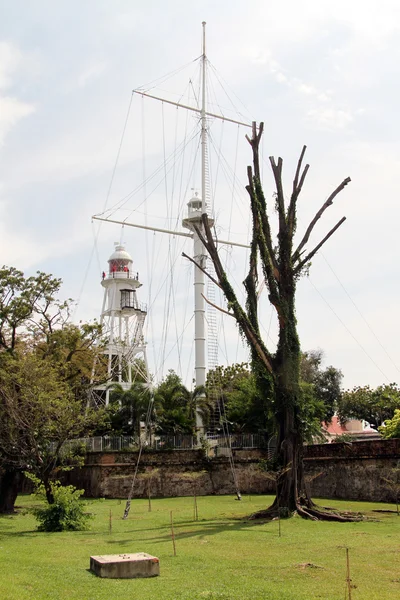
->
xmin=96 ymin=242 xmax=148 ymax=405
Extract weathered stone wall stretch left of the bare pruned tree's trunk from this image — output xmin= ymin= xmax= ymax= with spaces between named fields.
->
xmin=67 ymin=450 xmax=272 ymax=498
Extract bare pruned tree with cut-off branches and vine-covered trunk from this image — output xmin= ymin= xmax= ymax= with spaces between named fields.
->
xmin=188 ymin=123 xmax=356 ymax=520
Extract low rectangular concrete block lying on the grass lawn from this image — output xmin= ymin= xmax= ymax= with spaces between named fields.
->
xmin=90 ymin=552 xmax=160 ymax=579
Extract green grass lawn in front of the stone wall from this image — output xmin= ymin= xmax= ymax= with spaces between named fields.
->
xmin=0 ymin=496 xmax=400 ymax=600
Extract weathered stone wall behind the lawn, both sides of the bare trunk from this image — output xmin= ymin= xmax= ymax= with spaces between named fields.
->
xmin=67 ymin=440 xmax=400 ymax=501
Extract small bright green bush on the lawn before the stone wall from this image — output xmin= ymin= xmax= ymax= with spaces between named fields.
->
xmin=28 ymin=475 xmax=91 ymax=531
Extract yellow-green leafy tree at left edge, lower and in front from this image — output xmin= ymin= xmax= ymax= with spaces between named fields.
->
xmin=0 ymin=350 xmax=102 ymax=512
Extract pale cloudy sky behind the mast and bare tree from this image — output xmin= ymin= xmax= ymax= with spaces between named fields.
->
xmin=0 ymin=0 xmax=400 ymax=388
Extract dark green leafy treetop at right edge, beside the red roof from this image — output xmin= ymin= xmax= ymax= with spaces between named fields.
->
xmin=338 ymin=383 xmax=400 ymax=427
